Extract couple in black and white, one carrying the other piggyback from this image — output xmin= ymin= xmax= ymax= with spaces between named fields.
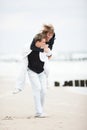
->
xmin=14 ymin=25 xmax=55 ymax=118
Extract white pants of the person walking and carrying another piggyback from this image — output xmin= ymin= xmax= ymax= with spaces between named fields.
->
xmin=28 ymin=69 xmax=47 ymax=114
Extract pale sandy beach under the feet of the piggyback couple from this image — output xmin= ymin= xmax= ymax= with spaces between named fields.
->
xmin=0 ymin=63 xmax=87 ymax=130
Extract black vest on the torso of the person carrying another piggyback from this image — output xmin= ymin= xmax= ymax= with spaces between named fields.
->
xmin=27 ymin=51 xmax=44 ymax=74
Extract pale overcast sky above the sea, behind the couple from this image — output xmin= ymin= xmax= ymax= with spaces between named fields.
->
xmin=0 ymin=0 xmax=87 ymax=55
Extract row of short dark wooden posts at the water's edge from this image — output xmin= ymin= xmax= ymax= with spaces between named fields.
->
xmin=54 ymin=79 xmax=87 ymax=87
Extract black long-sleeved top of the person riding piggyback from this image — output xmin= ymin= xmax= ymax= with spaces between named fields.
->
xmin=30 ymin=33 xmax=55 ymax=52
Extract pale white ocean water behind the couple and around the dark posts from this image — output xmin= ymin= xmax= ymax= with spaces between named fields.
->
xmin=0 ymin=60 xmax=87 ymax=86
